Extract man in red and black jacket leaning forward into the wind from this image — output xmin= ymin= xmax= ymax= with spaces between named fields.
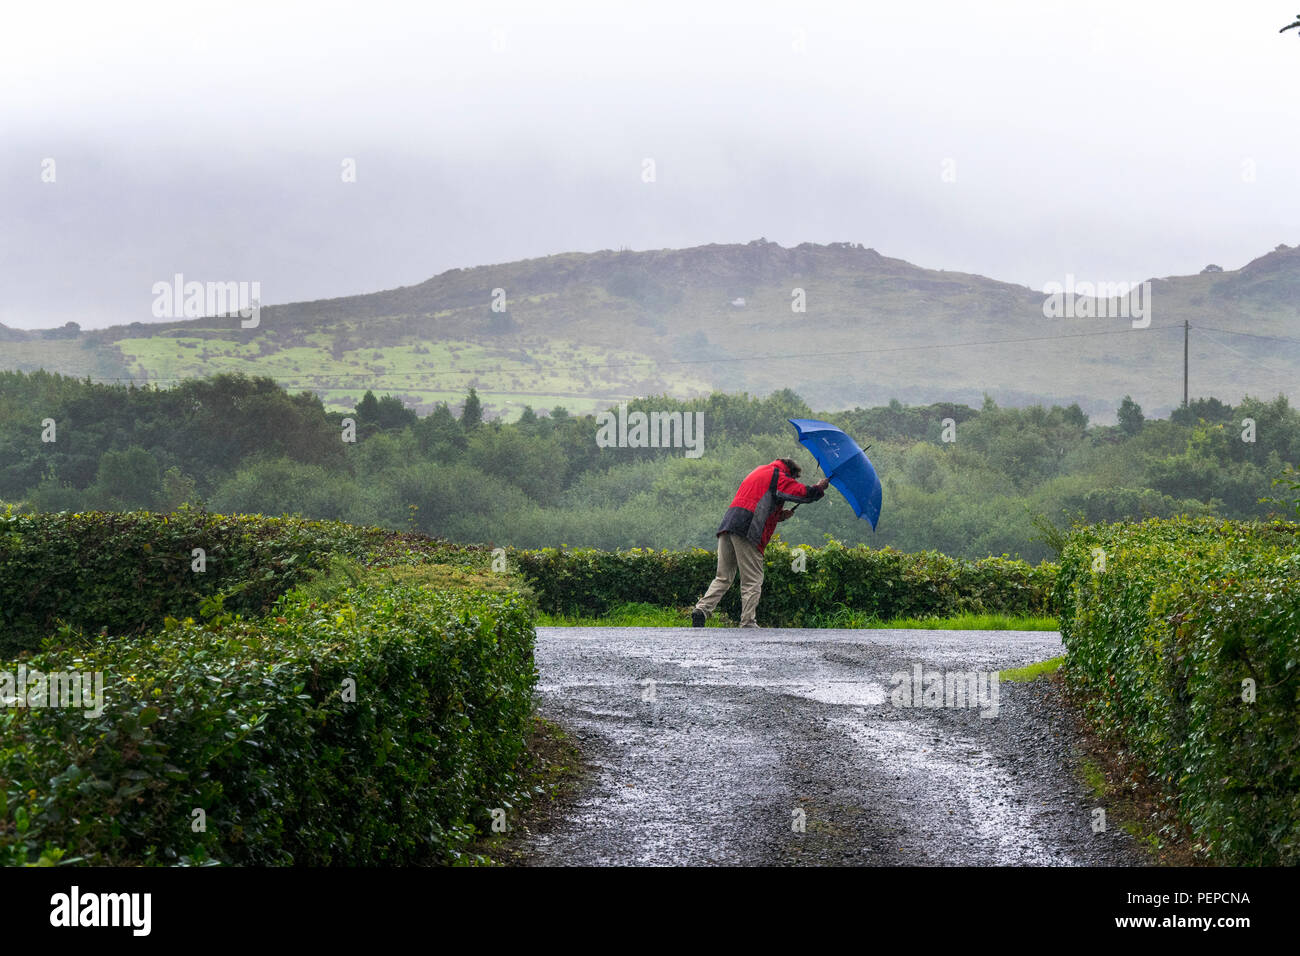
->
xmin=690 ymin=458 xmax=831 ymax=627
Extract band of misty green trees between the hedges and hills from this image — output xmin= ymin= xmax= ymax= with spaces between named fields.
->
xmin=0 ymin=372 xmax=1300 ymax=561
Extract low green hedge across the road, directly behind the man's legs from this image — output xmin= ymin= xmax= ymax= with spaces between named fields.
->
xmin=511 ymin=541 xmax=1056 ymax=627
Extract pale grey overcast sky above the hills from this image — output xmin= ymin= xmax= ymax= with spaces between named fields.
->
xmin=0 ymin=0 xmax=1300 ymax=328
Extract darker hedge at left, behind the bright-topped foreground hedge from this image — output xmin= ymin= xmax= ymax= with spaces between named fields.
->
xmin=0 ymin=509 xmax=488 ymax=658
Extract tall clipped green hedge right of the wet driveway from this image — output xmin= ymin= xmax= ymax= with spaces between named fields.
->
xmin=1057 ymin=519 xmax=1300 ymax=865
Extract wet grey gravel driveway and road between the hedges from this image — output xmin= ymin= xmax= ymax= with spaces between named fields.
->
xmin=520 ymin=627 xmax=1144 ymax=865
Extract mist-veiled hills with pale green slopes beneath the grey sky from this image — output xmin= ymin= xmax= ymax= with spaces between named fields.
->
xmin=0 ymin=239 xmax=1300 ymax=419
